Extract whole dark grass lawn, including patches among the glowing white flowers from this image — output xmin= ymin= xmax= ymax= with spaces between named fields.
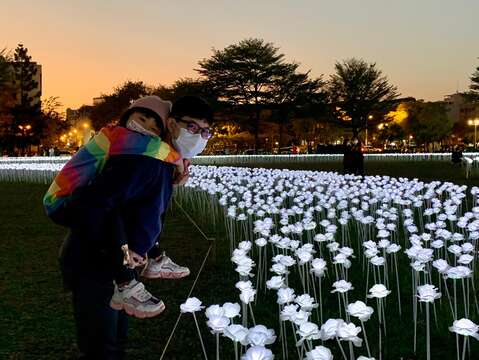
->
xmin=0 ymin=162 xmax=479 ymax=359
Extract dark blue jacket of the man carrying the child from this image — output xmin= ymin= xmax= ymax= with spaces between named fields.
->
xmin=64 ymin=155 xmax=174 ymax=256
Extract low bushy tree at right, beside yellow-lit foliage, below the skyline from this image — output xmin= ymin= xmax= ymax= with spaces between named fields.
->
xmin=409 ymin=102 xmax=454 ymax=146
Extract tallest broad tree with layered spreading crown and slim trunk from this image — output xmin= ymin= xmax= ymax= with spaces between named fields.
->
xmin=197 ymin=39 xmax=291 ymax=149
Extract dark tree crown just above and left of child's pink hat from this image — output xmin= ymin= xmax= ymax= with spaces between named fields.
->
xmin=90 ymin=81 xmax=153 ymax=129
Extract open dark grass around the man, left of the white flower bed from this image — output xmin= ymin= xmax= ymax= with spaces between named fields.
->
xmin=0 ymin=184 xmax=236 ymax=359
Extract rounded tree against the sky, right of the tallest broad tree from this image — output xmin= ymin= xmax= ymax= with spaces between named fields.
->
xmin=327 ymin=58 xmax=398 ymax=137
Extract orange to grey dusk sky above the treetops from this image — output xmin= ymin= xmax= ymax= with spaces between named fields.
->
xmin=0 ymin=0 xmax=479 ymax=107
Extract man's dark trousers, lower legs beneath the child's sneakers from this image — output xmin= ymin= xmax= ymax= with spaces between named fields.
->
xmin=72 ymin=277 xmax=128 ymax=360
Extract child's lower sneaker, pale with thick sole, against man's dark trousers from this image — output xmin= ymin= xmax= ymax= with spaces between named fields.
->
xmin=110 ymin=280 xmax=165 ymax=318
